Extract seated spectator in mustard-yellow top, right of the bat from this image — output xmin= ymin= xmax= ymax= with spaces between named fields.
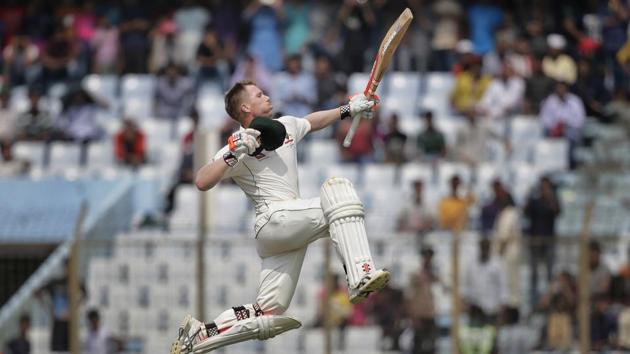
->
xmin=451 ymin=59 xmax=492 ymax=115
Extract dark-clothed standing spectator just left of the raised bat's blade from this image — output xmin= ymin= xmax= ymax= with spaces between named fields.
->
xmin=337 ymin=0 xmax=376 ymax=74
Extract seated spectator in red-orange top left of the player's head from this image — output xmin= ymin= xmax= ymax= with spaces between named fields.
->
xmin=114 ymin=118 xmax=146 ymax=167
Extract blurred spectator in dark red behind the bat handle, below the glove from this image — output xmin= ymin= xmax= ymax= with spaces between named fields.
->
xmin=335 ymin=119 xmax=376 ymax=163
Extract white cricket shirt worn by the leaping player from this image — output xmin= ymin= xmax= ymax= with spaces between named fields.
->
xmin=214 ymin=116 xmax=311 ymax=214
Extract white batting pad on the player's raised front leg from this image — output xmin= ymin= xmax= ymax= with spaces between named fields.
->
xmin=320 ymin=177 xmax=375 ymax=289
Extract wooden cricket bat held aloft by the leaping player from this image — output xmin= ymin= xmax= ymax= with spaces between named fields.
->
xmin=343 ymin=8 xmax=413 ymax=148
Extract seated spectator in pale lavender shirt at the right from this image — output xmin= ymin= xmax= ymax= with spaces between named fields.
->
xmin=540 ymin=82 xmax=586 ymax=169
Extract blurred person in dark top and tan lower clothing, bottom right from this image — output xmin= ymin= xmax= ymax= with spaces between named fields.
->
xmin=538 ymin=271 xmax=577 ymax=350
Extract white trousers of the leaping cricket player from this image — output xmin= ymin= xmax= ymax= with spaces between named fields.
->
xmin=214 ymin=198 xmax=329 ymax=332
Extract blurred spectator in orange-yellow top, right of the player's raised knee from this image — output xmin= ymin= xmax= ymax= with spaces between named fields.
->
xmin=438 ymin=175 xmax=475 ymax=232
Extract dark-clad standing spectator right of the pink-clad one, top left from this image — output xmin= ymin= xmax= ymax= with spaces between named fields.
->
xmin=119 ymin=0 xmax=150 ymax=74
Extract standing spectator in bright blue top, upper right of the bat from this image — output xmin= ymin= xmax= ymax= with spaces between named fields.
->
xmin=467 ymin=0 xmax=503 ymax=55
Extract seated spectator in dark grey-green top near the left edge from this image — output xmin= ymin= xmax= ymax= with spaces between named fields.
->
xmin=17 ymin=89 xmax=56 ymax=141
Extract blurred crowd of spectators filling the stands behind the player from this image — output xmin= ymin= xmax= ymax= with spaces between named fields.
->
xmin=0 ymin=0 xmax=630 ymax=353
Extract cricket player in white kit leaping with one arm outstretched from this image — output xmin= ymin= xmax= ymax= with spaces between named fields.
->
xmin=171 ymin=81 xmax=390 ymax=354
